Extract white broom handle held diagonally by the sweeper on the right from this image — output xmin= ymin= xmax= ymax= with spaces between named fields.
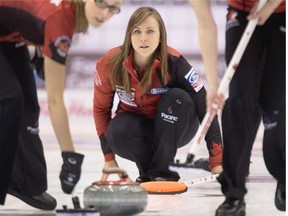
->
xmin=189 ymin=0 xmax=267 ymax=157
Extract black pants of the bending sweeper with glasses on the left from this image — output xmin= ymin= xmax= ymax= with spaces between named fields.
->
xmin=0 ymin=43 xmax=47 ymax=204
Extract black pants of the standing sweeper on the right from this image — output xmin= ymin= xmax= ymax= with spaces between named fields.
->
xmin=219 ymin=11 xmax=286 ymax=199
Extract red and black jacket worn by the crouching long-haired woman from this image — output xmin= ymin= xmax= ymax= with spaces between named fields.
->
xmin=93 ymin=47 xmax=222 ymax=158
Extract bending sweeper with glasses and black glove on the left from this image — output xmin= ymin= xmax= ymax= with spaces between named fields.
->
xmin=0 ymin=0 xmax=122 ymax=210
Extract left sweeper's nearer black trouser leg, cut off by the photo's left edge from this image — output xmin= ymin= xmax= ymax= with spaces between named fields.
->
xmin=0 ymin=43 xmax=23 ymax=204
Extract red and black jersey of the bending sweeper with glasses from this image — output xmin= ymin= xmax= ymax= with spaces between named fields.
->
xmin=0 ymin=0 xmax=76 ymax=64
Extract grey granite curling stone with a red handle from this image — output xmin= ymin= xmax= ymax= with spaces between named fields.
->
xmin=83 ymin=168 xmax=148 ymax=215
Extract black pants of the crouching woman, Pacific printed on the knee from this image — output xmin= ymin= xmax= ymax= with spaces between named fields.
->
xmin=107 ymin=88 xmax=199 ymax=180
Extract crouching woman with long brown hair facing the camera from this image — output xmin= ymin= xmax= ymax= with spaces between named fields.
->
xmin=93 ymin=7 xmax=222 ymax=183
